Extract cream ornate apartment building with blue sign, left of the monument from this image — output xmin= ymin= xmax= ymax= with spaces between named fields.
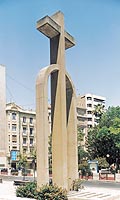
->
xmin=6 ymin=103 xmax=36 ymax=168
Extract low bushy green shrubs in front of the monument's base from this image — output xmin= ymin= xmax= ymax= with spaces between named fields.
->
xmin=16 ymin=182 xmax=68 ymax=200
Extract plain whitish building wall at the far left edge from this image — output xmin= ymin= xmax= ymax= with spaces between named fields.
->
xmin=0 ymin=65 xmax=7 ymax=167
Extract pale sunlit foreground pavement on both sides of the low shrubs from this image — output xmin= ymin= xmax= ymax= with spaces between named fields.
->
xmin=0 ymin=181 xmax=120 ymax=200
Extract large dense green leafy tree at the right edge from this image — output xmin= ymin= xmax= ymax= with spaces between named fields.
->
xmin=87 ymin=107 xmax=120 ymax=164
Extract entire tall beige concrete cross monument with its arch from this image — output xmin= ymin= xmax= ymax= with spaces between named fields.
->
xmin=36 ymin=11 xmax=78 ymax=189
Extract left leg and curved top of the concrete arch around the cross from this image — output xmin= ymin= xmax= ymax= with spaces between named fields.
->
xmin=36 ymin=64 xmax=58 ymax=187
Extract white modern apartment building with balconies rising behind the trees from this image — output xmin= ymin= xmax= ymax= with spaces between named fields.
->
xmin=79 ymin=94 xmax=106 ymax=128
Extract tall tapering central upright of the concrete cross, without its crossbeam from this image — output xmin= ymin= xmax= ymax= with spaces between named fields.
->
xmin=50 ymin=12 xmax=68 ymax=188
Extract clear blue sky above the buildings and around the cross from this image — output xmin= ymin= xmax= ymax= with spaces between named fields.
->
xmin=0 ymin=0 xmax=120 ymax=109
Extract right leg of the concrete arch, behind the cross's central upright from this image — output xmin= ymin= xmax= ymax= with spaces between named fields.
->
xmin=66 ymin=72 xmax=78 ymax=189
